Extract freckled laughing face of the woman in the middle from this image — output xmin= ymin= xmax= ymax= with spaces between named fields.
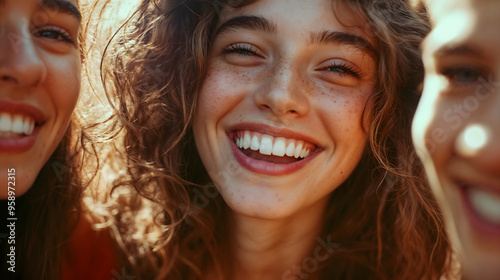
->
xmin=193 ymin=0 xmax=376 ymax=219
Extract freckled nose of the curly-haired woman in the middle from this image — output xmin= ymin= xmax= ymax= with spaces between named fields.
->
xmin=254 ymin=63 xmax=310 ymax=116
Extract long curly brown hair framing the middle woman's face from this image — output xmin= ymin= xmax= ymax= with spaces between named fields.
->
xmin=101 ymin=0 xmax=456 ymax=279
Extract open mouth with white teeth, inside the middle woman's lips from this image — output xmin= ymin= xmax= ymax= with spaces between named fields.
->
xmin=233 ymin=131 xmax=317 ymax=164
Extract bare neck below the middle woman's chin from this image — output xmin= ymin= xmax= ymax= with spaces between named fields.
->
xmin=226 ymin=198 xmax=328 ymax=280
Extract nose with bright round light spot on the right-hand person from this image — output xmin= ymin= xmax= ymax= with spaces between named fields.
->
xmin=455 ymin=93 xmax=500 ymax=177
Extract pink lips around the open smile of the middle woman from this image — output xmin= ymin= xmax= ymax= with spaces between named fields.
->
xmin=228 ymin=124 xmax=322 ymax=176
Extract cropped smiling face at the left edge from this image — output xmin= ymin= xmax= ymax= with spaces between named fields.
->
xmin=0 ymin=0 xmax=81 ymax=199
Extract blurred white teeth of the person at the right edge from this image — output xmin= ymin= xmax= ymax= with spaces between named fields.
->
xmin=469 ymin=188 xmax=500 ymax=224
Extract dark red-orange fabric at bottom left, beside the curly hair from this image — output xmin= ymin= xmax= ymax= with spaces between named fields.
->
xmin=62 ymin=216 xmax=119 ymax=280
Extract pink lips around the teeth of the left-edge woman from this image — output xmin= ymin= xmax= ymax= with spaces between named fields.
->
xmin=0 ymin=100 xmax=45 ymax=153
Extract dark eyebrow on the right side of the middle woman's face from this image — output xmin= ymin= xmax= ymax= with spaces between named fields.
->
xmin=310 ymin=31 xmax=377 ymax=58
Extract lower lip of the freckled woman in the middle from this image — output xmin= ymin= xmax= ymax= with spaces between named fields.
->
xmin=228 ymin=137 xmax=319 ymax=176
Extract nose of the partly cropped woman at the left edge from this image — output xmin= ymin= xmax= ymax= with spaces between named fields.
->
xmin=0 ymin=19 xmax=47 ymax=86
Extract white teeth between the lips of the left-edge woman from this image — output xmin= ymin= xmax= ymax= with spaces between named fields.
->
xmin=0 ymin=112 xmax=36 ymax=138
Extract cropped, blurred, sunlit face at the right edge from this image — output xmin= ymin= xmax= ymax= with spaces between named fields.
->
xmin=413 ymin=0 xmax=500 ymax=279
